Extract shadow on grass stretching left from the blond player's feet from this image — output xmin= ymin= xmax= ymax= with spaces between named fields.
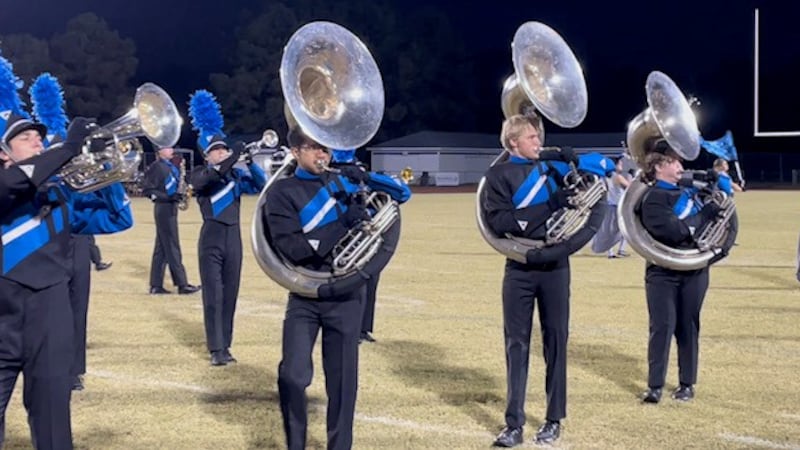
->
xmin=375 ymin=341 xmax=505 ymax=432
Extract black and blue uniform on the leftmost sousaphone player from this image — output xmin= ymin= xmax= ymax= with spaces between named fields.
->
xmin=264 ymin=168 xmax=411 ymax=450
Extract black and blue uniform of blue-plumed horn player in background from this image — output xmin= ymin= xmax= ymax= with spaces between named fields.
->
xmin=191 ymin=151 xmax=267 ymax=362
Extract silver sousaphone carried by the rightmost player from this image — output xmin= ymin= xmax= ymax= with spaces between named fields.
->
xmin=617 ymin=71 xmax=738 ymax=270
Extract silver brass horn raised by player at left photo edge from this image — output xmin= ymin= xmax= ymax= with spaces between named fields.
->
xmin=60 ymin=83 xmax=183 ymax=192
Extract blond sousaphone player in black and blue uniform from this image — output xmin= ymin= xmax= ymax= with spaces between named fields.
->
xmin=485 ymin=114 xmax=571 ymax=447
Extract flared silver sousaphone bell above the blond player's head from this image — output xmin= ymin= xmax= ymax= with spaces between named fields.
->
xmin=511 ymin=22 xmax=589 ymax=128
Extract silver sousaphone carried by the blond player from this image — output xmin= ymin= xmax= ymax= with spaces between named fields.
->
xmin=476 ymin=22 xmax=606 ymax=263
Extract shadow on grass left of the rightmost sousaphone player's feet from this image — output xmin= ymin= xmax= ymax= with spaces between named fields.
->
xmin=567 ymin=339 xmax=647 ymax=395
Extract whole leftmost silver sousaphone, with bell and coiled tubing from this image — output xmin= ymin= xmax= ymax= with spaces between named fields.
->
xmin=251 ymin=22 xmax=400 ymax=298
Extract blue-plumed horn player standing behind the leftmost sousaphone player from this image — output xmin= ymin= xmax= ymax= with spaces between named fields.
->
xmin=189 ymin=90 xmax=267 ymax=366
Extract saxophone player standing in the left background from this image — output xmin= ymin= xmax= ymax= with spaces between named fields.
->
xmin=142 ymin=147 xmax=200 ymax=294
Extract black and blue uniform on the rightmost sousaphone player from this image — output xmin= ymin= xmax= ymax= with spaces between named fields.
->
xmin=641 ymin=181 xmax=718 ymax=389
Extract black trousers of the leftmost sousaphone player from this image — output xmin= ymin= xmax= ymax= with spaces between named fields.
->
xmin=278 ymin=288 xmax=363 ymax=450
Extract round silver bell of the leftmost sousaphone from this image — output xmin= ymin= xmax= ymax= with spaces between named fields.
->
xmin=280 ymin=22 xmax=384 ymax=148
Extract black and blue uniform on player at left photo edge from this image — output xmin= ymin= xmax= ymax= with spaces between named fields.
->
xmin=0 ymin=124 xmax=133 ymax=449
